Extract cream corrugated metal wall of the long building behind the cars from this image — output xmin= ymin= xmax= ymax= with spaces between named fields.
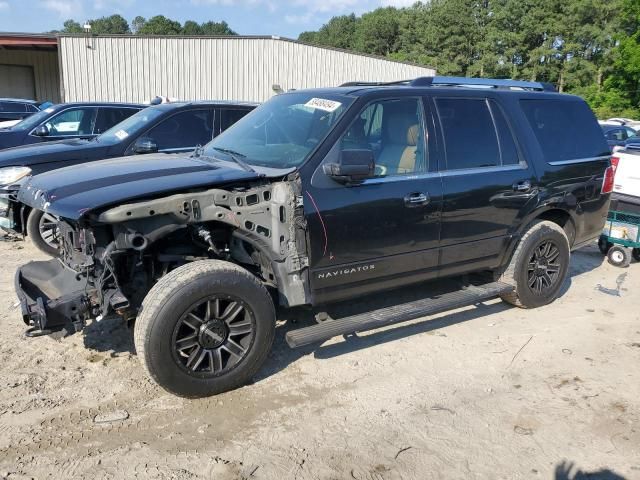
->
xmin=59 ymin=37 xmax=435 ymax=102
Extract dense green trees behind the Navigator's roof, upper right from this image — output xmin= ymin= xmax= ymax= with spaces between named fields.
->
xmin=299 ymin=0 xmax=640 ymax=118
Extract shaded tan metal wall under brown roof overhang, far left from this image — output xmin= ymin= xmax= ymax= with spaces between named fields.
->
xmin=0 ymin=49 xmax=60 ymax=102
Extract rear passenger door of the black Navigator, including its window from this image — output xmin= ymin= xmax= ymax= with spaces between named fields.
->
xmin=435 ymin=97 xmax=536 ymax=275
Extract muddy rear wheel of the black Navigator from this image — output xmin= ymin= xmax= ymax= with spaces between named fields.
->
xmin=500 ymin=220 xmax=571 ymax=308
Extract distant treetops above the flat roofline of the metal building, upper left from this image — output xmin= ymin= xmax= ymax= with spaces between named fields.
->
xmin=52 ymin=14 xmax=237 ymax=35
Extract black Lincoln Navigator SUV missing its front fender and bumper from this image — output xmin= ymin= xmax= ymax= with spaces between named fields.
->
xmin=16 ymin=77 xmax=613 ymax=397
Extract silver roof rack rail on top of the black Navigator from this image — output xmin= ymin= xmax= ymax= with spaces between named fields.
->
xmin=340 ymin=77 xmax=556 ymax=92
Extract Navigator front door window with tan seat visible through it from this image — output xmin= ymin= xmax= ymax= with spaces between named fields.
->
xmin=340 ymin=98 xmax=427 ymax=177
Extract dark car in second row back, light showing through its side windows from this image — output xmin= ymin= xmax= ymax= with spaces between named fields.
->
xmin=0 ymin=103 xmax=145 ymax=149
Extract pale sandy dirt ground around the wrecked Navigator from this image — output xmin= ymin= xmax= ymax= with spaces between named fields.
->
xmin=0 ymin=238 xmax=640 ymax=480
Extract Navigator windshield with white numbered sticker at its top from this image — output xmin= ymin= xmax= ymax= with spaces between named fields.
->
xmin=204 ymin=92 xmax=353 ymax=168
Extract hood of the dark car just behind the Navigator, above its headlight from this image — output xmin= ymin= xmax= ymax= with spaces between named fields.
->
xmin=0 ymin=138 xmax=108 ymax=168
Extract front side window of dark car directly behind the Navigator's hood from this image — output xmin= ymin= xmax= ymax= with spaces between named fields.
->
xmin=144 ymin=110 xmax=213 ymax=151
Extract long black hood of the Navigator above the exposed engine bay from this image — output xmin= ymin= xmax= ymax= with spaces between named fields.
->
xmin=18 ymin=154 xmax=260 ymax=220
